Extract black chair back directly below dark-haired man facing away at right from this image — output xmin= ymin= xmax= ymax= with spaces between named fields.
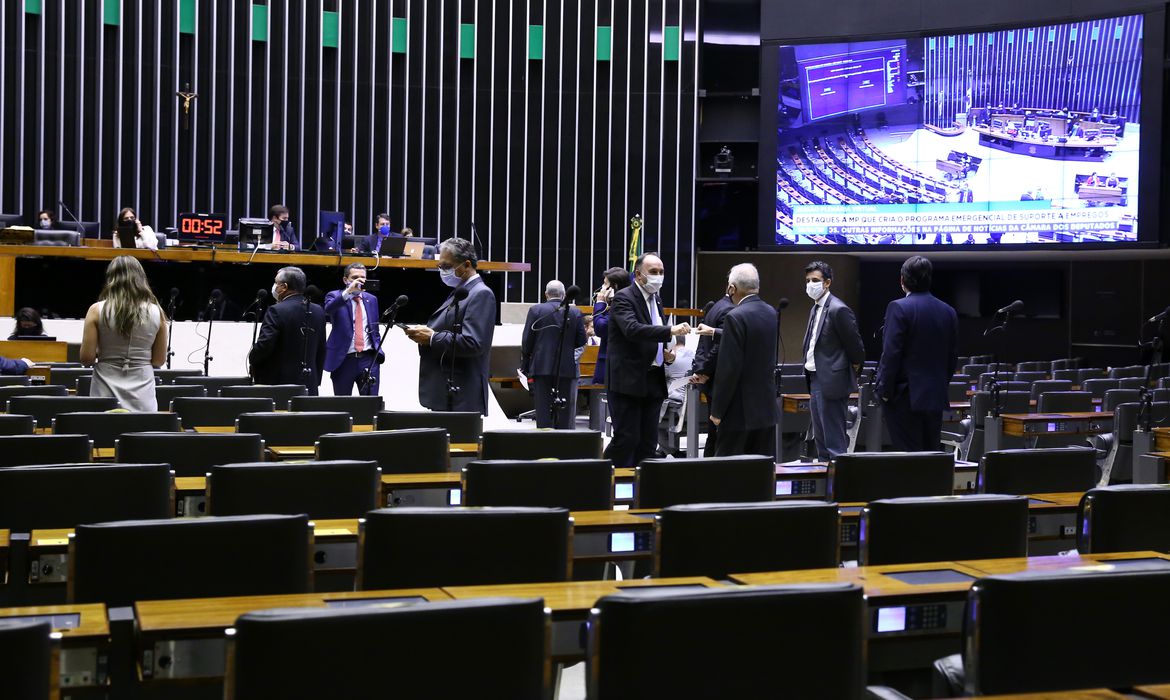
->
xmin=825 ymin=452 xmax=955 ymax=503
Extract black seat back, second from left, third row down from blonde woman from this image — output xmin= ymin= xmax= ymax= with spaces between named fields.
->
xmin=115 ymin=433 xmax=264 ymax=476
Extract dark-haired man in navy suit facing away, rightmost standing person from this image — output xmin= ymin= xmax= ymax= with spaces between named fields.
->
xmin=878 ymin=255 xmax=958 ymax=452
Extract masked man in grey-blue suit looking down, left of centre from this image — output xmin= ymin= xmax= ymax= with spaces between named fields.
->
xmin=406 ymin=238 xmax=496 ymax=416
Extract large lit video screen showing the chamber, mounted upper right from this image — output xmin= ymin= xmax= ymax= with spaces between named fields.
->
xmin=773 ymin=15 xmax=1141 ymax=246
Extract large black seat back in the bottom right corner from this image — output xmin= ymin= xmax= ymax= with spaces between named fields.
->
xmin=964 ymin=571 xmax=1170 ymax=695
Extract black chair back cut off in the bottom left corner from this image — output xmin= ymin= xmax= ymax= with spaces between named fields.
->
xmin=0 ymin=618 xmax=53 ymax=700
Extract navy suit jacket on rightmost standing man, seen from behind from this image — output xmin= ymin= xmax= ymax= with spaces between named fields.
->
xmin=878 ymin=291 xmax=958 ymax=411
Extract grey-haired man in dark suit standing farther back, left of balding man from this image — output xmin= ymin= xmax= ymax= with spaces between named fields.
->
xmin=519 ymin=280 xmax=585 ymax=430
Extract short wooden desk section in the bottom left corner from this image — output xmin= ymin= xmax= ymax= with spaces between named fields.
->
xmin=0 ymin=604 xmax=110 ymax=696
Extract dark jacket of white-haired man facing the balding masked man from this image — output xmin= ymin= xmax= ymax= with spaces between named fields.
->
xmin=710 ymin=295 xmax=779 ymax=431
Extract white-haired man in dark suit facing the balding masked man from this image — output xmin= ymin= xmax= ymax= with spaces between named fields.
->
xmin=710 ymin=262 xmax=779 ymax=457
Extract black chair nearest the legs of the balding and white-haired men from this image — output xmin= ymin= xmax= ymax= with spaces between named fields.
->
xmin=634 ymin=454 xmax=776 ymax=508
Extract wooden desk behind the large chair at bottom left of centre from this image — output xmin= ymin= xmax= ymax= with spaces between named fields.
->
xmin=135 ymin=588 xmax=449 ymax=682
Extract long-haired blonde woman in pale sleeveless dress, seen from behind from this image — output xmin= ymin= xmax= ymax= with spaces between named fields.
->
xmin=81 ymin=255 xmax=166 ymax=411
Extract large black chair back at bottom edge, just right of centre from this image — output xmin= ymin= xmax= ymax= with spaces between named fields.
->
xmin=585 ymin=583 xmax=866 ymax=700
